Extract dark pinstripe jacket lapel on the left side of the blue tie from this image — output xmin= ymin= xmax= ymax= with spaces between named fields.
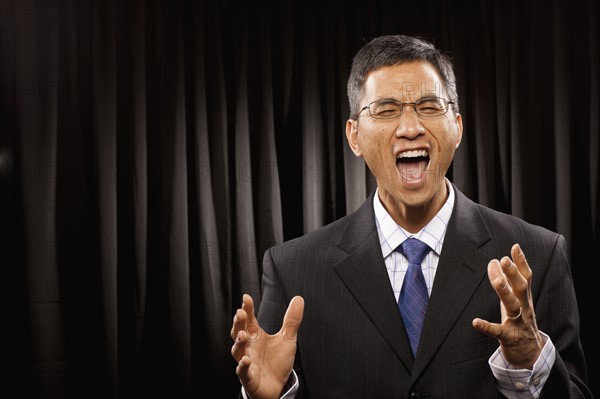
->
xmin=334 ymin=195 xmax=414 ymax=370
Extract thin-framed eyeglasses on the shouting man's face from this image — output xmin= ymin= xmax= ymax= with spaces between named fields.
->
xmin=356 ymin=97 xmax=454 ymax=119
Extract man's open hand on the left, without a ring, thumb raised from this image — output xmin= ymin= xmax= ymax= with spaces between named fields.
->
xmin=231 ymin=294 xmax=304 ymax=399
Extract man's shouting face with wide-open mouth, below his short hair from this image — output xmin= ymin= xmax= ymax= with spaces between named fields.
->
xmin=346 ymin=61 xmax=462 ymax=220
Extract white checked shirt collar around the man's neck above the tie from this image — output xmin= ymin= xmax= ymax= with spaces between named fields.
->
xmin=373 ymin=179 xmax=454 ymax=259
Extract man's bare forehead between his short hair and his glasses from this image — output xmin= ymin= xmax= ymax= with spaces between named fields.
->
xmin=364 ymin=61 xmax=445 ymax=101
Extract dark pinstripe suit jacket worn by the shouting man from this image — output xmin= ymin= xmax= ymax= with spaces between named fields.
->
xmin=258 ymin=187 xmax=592 ymax=399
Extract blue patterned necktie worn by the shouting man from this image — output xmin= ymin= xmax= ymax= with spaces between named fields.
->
xmin=396 ymin=238 xmax=431 ymax=356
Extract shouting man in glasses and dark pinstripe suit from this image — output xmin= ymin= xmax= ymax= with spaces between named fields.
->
xmin=231 ymin=36 xmax=592 ymax=399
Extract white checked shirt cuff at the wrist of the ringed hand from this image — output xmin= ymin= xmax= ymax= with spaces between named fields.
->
xmin=488 ymin=331 xmax=556 ymax=399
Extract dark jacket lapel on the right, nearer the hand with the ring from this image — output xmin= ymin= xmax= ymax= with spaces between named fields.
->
xmin=413 ymin=187 xmax=491 ymax=380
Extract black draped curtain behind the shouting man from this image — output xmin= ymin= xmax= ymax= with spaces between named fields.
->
xmin=0 ymin=0 xmax=600 ymax=399
